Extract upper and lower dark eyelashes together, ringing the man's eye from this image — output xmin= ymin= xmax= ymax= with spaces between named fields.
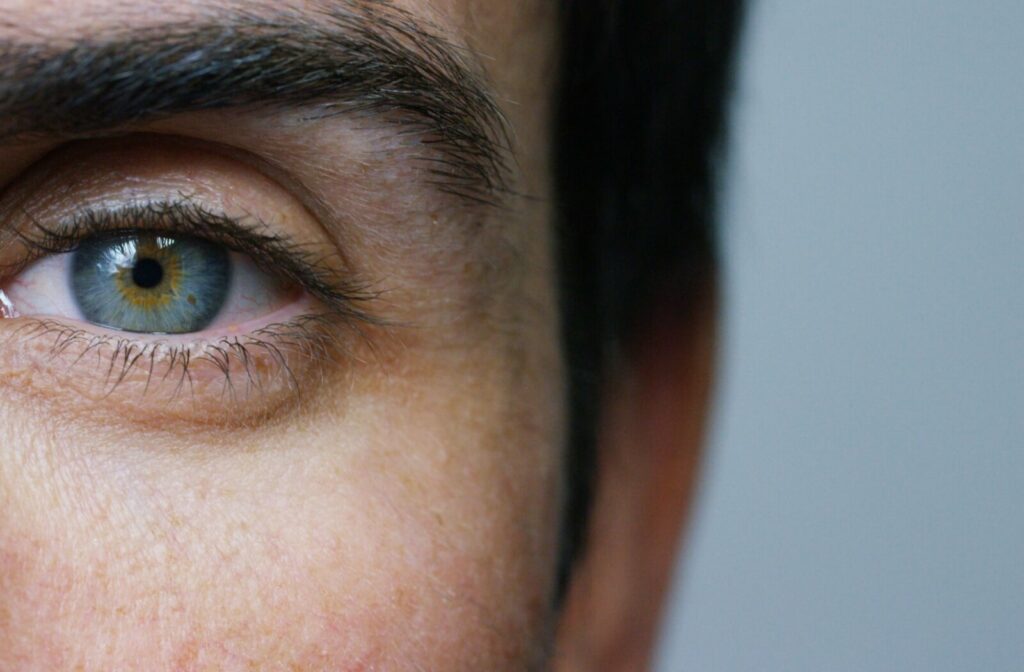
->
xmin=0 ymin=197 xmax=383 ymax=397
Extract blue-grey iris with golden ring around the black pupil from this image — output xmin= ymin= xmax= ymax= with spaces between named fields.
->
xmin=71 ymin=236 xmax=231 ymax=334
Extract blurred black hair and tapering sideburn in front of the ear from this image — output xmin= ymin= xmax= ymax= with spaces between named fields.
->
xmin=553 ymin=0 xmax=742 ymax=593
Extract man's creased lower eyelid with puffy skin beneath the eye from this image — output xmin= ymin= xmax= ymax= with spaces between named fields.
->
xmin=0 ymin=310 xmax=350 ymax=425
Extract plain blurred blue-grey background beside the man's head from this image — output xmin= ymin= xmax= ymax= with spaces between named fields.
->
xmin=657 ymin=0 xmax=1024 ymax=672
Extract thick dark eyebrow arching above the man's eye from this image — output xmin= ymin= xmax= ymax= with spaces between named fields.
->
xmin=0 ymin=2 xmax=511 ymax=203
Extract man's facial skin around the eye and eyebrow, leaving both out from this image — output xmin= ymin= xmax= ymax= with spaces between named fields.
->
xmin=0 ymin=0 xmax=564 ymax=670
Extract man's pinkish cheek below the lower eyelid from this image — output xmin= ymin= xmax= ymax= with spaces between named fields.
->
xmin=0 ymin=344 xmax=560 ymax=670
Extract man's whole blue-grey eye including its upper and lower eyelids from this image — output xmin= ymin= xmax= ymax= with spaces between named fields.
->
xmin=0 ymin=138 xmax=374 ymax=420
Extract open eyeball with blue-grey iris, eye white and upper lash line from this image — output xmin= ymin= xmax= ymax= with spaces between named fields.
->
xmin=9 ymin=210 xmax=303 ymax=338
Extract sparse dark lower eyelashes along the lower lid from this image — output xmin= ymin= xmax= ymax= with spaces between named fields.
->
xmin=4 ymin=313 xmax=360 ymax=404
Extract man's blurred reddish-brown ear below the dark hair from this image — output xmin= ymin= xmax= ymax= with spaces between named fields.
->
xmin=555 ymin=291 xmax=716 ymax=672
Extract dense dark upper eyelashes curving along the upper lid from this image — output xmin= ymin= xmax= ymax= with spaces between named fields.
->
xmin=6 ymin=195 xmax=381 ymax=325
